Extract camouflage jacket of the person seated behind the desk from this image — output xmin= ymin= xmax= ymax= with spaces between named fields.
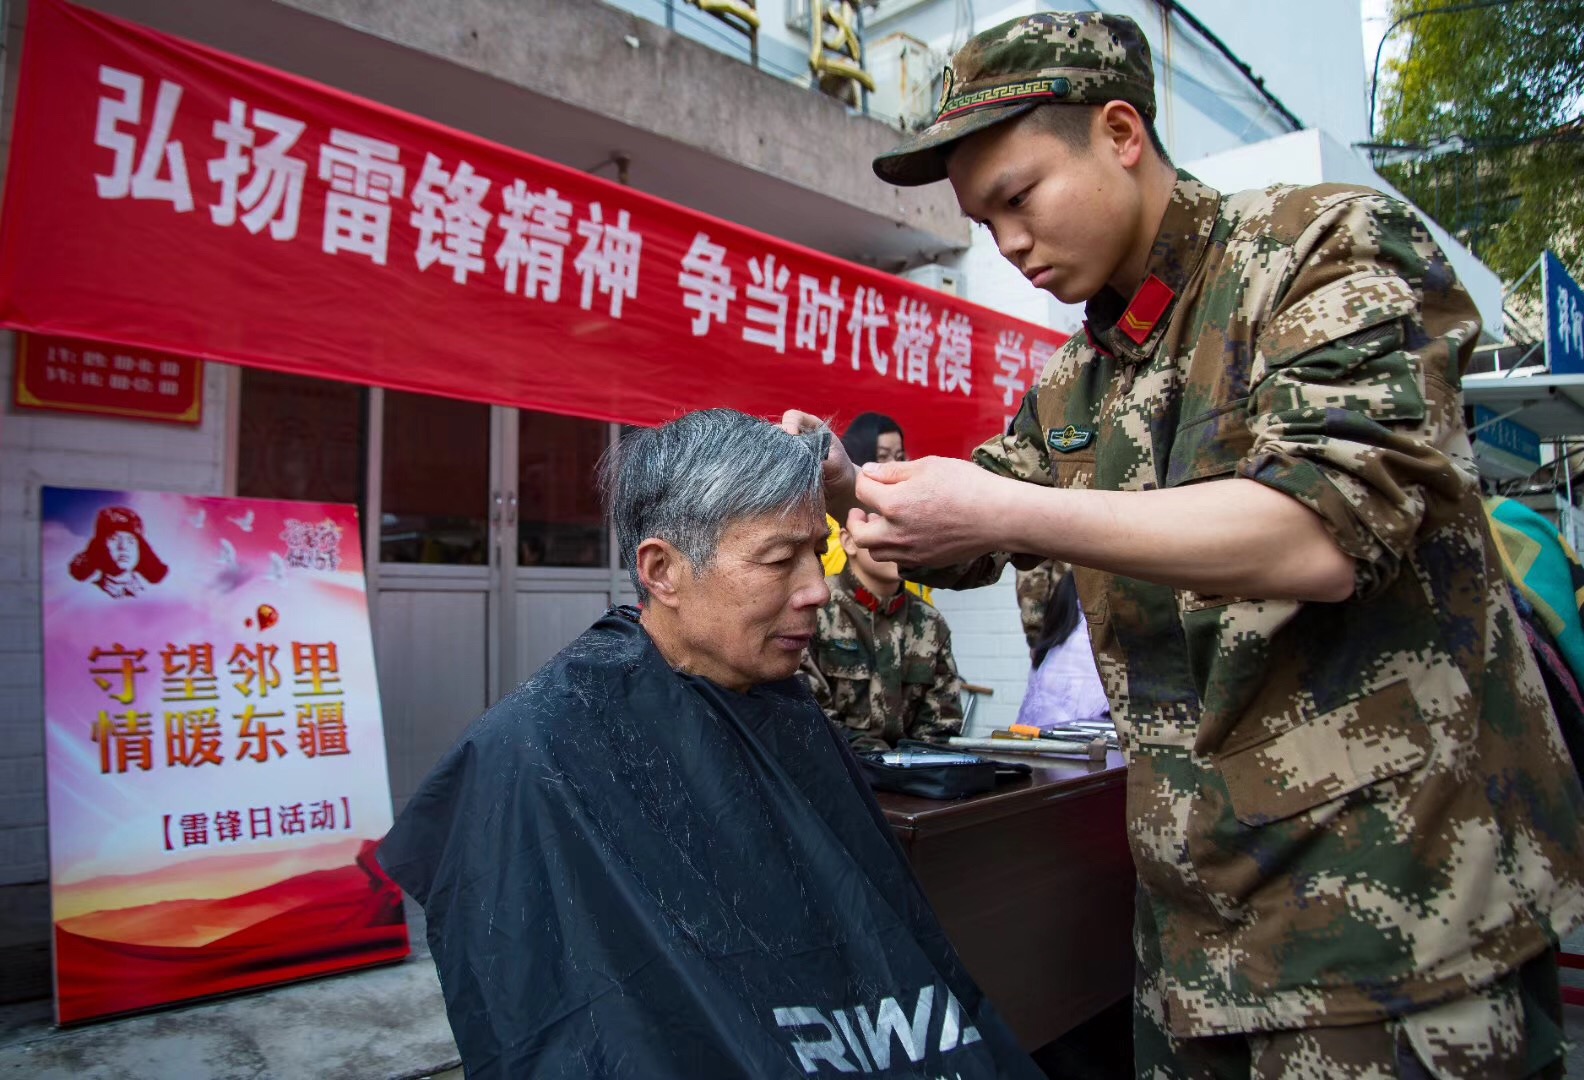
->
xmin=803 ymin=570 xmax=963 ymax=749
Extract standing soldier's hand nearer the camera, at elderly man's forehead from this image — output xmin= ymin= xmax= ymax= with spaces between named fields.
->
xmin=846 ymin=458 xmax=995 ymax=567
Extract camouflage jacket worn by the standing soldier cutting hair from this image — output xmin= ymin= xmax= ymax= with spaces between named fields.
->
xmin=914 ymin=174 xmax=1584 ymax=1036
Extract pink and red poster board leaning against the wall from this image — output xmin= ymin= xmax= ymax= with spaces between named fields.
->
xmin=41 ymin=488 xmax=407 ymax=1023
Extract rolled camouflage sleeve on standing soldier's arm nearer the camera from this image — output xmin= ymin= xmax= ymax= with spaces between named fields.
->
xmin=1237 ymin=196 xmax=1479 ymax=597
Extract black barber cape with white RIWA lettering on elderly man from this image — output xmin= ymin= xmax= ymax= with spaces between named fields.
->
xmin=380 ymin=608 xmax=1041 ymax=1080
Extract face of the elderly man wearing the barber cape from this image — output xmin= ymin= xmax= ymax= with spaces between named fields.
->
xmin=675 ymin=513 xmax=830 ymax=690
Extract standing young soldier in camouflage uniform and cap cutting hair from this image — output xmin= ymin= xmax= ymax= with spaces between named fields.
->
xmin=782 ymin=13 xmax=1584 ymax=1078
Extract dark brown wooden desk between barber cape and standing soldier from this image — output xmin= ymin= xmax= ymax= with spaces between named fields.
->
xmin=878 ymin=752 xmax=1134 ymax=1050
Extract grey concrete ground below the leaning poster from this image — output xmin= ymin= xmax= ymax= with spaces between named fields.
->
xmin=0 ymin=901 xmax=463 ymax=1080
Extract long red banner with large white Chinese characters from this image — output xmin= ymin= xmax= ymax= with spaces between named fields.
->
xmin=0 ymin=0 xmax=1063 ymax=453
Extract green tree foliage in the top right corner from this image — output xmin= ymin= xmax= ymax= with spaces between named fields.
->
xmin=1376 ymin=0 xmax=1584 ymax=291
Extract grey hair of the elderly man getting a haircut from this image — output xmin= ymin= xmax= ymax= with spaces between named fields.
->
xmin=599 ymin=409 xmax=830 ymax=600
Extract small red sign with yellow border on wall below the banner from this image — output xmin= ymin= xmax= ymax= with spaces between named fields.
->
xmin=13 ymin=334 xmax=203 ymax=424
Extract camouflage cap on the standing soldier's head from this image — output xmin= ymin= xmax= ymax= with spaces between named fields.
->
xmin=874 ymin=11 xmax=1155 ymax=187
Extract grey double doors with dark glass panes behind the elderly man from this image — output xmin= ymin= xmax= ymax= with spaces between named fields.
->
xmin=236 ymin=369 xmax=632 ymax=809
